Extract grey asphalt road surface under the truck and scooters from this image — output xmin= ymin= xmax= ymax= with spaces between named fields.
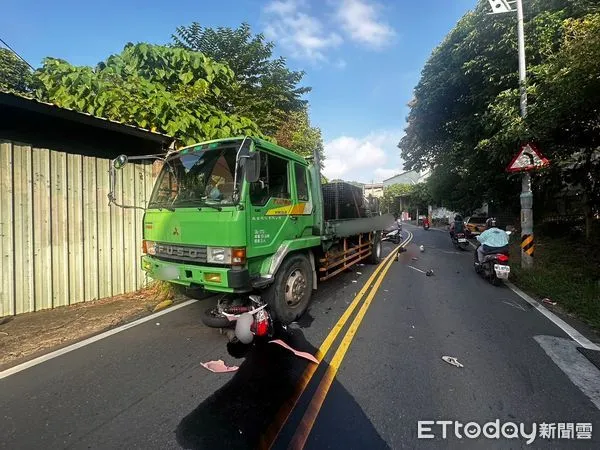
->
xmin=0 ymin=226 xmax=600 ymax=449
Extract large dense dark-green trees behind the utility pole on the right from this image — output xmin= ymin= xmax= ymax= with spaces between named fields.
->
xmin=399 ymin=0 xmax=600 ymax=236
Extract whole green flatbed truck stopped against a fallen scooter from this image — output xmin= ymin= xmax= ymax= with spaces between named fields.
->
xmin=109 ymin=137 xmax=394 ymax=324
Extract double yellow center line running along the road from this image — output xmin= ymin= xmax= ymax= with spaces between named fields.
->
xmin=260 ymin=231 xmax=413 ymax=449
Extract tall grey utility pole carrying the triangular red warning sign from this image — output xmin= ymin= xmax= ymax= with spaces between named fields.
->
xmin=488 ymin=0 xmax=533 ymax=269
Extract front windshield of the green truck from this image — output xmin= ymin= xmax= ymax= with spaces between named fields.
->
xmin=148 ymin=146 xmax=240 ymax=208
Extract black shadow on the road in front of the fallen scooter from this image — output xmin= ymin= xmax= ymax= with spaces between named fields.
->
xmin=175 ymin=328 xmax=386 ymax=449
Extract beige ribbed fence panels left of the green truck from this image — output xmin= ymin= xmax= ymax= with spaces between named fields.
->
xmin=0 ymin=141 xmax=154 ymax=317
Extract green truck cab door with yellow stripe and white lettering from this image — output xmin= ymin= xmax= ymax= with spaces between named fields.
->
xmin=247 ymin=149 xmax=298 ymax=258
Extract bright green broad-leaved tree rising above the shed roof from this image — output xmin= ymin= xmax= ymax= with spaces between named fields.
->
xmin=35 ymin=43 xmax=261 ymax=144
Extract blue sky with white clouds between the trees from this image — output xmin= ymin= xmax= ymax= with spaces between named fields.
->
xmin=0 ymin=0 xmax=477 ymax=183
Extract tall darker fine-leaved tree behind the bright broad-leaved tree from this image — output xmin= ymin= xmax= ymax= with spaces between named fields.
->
xmin=173 ymin=22 xmax=310 ymax=135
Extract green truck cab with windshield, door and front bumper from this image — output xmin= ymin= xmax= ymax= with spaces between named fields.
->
xmin=142 ymin=137 xmax=320 ymax=293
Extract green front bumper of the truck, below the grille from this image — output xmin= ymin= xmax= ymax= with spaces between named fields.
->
xmin=141 ymin=255 xmax=252 ymax=293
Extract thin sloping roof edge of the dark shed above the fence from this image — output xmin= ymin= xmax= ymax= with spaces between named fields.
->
xmin=0 ymin=90 xmax=174 ymax=144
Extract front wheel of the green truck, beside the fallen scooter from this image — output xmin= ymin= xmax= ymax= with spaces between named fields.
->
xmin=263 ymin=253 xmax=313 ymax=325
